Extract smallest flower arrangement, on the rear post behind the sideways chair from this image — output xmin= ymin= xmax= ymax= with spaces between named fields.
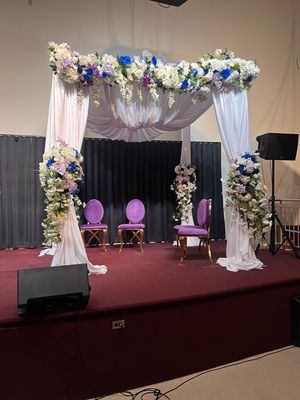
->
xmin=171 ymin=164 xmax=197 ymax=221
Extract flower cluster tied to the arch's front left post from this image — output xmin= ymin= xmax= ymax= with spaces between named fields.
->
xmin=39 ymin=141 xmax=83 ymax=247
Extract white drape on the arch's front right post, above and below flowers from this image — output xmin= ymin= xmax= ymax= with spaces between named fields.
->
xmin=213 ymin=90 xmax=263 ymax=272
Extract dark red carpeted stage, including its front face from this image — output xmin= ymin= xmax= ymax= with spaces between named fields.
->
xmin=0 ymin=241 xmax=300 ymax=400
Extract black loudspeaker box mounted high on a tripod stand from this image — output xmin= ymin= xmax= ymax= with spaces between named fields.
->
xmin=256 ymin=133 xmax=298 ymax=160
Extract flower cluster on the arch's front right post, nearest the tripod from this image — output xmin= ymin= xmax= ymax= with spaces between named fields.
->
xmin=226 ymin=153 xmax=272 ymax=243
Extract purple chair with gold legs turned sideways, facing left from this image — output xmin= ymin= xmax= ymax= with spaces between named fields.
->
xmin=174 ymin=199 xmax=212 ymax=262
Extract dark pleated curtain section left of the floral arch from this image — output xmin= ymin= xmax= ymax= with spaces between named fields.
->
xmin=0 ymin=135 xmax=45 ymax=249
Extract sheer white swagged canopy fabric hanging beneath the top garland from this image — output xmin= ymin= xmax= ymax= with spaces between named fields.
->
xmin=87 ymin=85 xmax=213 ymax=142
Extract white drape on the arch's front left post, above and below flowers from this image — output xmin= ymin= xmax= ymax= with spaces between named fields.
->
xmin=45 ymin=75 xmax=107 ymax=274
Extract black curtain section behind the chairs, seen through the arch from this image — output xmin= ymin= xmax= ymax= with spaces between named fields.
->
xmin=81 ymin=139 xmax=225 ymax=243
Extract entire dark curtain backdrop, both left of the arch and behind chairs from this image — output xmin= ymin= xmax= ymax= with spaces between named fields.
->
xmin=0 ymin=135 xmax=225 ymax=249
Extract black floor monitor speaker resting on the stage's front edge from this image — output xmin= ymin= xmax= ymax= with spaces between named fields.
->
xmin=17 ymin=264 xmax=90 ymax=315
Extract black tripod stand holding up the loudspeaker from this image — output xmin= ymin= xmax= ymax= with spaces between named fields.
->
xmin=269 ymin=160 xmax=300 ymax=259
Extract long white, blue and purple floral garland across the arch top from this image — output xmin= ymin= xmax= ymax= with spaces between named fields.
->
xmin=48 ymin=42 xmax=260 ymax=107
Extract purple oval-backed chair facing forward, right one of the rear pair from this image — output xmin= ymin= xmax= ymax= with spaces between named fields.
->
xmin=118 ymin=199 xmax=145 ymax=252
